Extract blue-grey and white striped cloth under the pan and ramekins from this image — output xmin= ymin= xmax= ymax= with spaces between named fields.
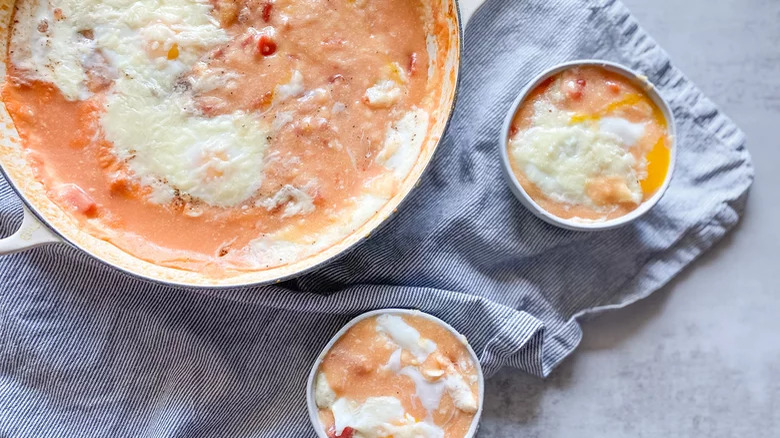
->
xmin=0 ymin=0 xmax=752 ymax=438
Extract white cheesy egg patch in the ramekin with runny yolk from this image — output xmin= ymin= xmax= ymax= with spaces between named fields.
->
xmin=509 ymin=101 xmax=642 ymax=210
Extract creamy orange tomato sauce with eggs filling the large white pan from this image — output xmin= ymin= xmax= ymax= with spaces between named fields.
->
xmin=2 ymin=0 xmax=446 ymax=277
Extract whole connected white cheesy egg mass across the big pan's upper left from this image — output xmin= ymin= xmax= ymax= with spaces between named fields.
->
xmin=14 ymin=0 xmax=272 ymax=207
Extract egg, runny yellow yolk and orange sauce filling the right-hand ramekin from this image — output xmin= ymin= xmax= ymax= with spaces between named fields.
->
xmin=507 ymin=67 xmax=669 ymax=221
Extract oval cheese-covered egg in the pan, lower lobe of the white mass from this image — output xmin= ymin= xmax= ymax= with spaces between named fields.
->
xmin=102 ymin=82 xmax=266 ymax=207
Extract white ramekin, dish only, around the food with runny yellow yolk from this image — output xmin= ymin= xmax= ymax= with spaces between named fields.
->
xmin=499 ymin=59 xmax=677 ymax=231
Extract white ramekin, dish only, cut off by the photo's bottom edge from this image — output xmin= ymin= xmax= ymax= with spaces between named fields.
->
xmin=306 ymin=309 xmax=485 ymax=438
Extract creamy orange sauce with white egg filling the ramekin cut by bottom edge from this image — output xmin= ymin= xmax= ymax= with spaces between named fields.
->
xmin=314 ymin=314 xmax=479 ymax=438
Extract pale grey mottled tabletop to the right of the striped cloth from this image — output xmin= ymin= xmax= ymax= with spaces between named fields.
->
xmin=476 ymin=0 xmax=780 ymax=438
